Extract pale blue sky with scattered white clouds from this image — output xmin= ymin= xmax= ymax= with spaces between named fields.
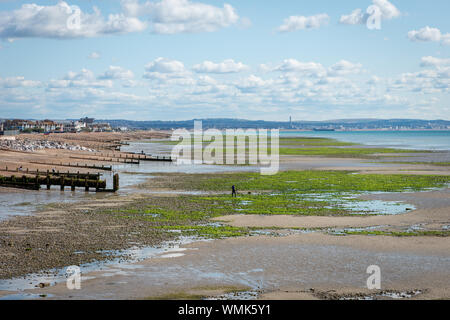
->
xmin=0 ymin=0 xmax=450 ymax=120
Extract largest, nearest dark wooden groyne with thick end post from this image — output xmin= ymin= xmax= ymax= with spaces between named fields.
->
xmin=0 ymin=174 xmax=119 ymax=192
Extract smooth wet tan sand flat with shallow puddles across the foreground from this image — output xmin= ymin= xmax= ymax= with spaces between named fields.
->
xmin=29 ymin=230 xmax=450 ymax=299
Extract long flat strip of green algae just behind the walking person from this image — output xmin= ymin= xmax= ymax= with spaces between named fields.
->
xmin=141 ymin=171 xmax=450 ymax=193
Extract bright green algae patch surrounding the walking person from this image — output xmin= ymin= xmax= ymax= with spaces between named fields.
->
xmin=126 ymin=171 xmax=450 ymax=234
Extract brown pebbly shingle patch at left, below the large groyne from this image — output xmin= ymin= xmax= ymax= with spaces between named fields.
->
xmin=0 ymin=195 xmax=174 ymax=280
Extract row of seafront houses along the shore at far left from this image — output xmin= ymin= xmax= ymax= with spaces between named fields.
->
xmin=0 ymin=118 xmax=112 ymax=135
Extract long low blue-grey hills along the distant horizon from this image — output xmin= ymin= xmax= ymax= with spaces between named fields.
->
xmin=95 ymin=119 xmax=450 ymax=130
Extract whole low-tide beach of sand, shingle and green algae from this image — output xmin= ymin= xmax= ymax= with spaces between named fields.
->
xmin=0 ymin=133 xmax=450 ymax=299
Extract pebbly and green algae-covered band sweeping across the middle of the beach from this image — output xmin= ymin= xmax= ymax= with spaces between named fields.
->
xmin=0 ymin=165 xmax=450 ymax=277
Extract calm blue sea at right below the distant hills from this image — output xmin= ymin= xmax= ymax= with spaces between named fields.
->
xmin=280 ymin=131 xmax=450 ymax=151
